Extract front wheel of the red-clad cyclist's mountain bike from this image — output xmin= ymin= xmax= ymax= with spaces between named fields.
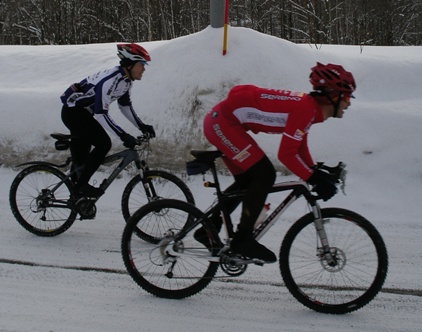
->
xmin=279 ymin=208 xmax=388 ymax=314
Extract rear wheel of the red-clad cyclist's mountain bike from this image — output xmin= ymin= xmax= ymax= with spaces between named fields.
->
xmin=121 ymin=199 xmax=219 ymax=299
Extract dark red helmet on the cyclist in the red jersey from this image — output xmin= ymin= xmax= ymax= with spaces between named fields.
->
xmin=309 ymin=62 xmax=356 ymax=94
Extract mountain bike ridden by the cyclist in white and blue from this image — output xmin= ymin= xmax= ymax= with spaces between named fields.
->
xmin=9 ymin=133 xmax=195 ymax=238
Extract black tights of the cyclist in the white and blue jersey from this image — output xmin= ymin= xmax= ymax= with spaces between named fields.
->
xmin=62 ymin=106 xmax=111 ymax=186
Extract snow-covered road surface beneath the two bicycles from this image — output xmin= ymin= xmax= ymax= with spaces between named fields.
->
xmin=0 ymin=169 xmax=422 ymax=332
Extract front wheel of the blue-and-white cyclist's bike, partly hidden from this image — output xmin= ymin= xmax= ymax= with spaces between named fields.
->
xmin=122 ymin=170 xmax=195 ymax=243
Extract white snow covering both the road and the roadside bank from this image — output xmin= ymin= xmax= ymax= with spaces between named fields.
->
xmin=0 ymin=28 xmax=422 ymax=332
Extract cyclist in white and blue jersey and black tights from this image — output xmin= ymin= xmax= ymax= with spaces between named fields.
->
xmin=60 ymin=43 xmax=155 ymax=197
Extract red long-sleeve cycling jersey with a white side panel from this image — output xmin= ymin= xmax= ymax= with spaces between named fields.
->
xmin=218 ymin=85 xmax=323 ymax=180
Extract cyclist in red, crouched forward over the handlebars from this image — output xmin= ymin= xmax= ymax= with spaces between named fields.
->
xmin=195 ymin=63 xmax=356 ymax=262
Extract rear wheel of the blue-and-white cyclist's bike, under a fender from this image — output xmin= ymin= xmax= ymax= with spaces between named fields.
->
xmin=9 ymin=165 xmax=77 ymax=237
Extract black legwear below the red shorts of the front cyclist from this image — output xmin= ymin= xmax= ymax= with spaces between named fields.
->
xmin=218 ymin=156 xmax=276 ymax=232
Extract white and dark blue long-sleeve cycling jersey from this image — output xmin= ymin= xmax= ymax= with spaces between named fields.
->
xmin=60 ymin=66 xmax=143 ymax=137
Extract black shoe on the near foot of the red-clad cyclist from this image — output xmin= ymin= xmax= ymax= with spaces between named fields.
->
xmin=230 ymin=231 xmax=277 ymax=263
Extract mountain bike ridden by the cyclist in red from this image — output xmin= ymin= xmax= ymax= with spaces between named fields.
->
xmin=121 ymin=151 xmax=388 ymax=314
